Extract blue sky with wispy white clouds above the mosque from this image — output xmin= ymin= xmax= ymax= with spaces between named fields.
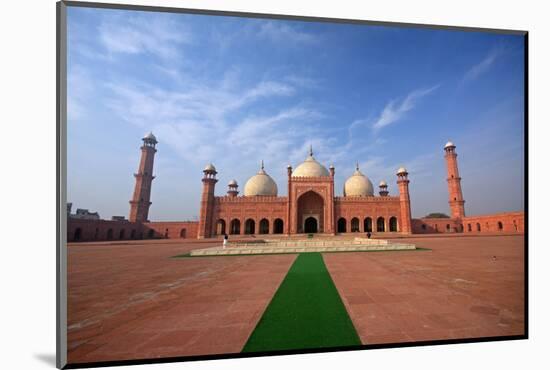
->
xmin=67 ymin=7 xmax=525 ymax=221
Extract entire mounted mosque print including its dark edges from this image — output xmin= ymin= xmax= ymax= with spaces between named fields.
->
xmin=57 ymin=1 xmax=528 ymax=368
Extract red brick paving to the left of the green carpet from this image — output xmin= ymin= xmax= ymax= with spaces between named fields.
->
xmin=68 ymin=241 xmax=295 ymax=363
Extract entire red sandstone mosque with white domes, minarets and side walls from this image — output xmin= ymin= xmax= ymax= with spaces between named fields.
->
xmin=67 ymin=133 xmax=524 ymax=242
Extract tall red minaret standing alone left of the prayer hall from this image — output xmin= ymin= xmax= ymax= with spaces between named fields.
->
xmin=128 ymin=132 xmax=157 ymax=222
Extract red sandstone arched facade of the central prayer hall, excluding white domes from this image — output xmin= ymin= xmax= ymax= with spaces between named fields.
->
xmin=198 ymin=156 xmax=410 ymax=238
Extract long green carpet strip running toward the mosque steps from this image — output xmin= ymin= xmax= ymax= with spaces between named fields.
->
xmin=243 ymin=253 xmax=361 ymax=352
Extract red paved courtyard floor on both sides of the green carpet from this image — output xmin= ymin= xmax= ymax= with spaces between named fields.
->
xmin=68 ymin=236 xmax=524 ymax=363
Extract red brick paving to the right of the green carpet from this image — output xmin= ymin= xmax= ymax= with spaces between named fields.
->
xmin=324 ymin=236 xmax=524 ymax=344
